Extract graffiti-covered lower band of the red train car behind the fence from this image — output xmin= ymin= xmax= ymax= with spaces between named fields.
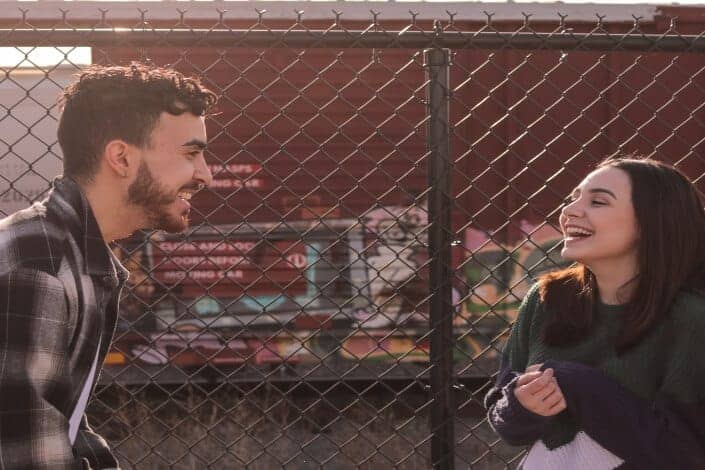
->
xmin=107 ymin=214 xmax=566 ymax=367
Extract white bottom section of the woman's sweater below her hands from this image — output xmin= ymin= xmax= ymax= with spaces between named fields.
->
xmin=519 ymin=431 xmax=624 ymax=470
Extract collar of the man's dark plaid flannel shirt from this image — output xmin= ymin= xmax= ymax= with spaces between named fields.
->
xmin=49 ymin=176 xmax=129 ymax=285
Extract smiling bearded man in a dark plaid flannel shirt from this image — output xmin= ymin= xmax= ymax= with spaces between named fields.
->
xmin=0 ymin=63 xmax=216 ymax=470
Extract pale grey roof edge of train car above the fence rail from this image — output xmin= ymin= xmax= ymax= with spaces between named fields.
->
xmin=0 ymin=0 xmax=664 ymax=23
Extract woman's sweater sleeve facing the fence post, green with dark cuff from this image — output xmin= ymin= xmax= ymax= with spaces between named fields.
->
xmin=485 ymin=286 xmax=551 ymax=446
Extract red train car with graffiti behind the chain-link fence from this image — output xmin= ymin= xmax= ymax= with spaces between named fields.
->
xmin=0 ymin=4 xmax=705 ymax=378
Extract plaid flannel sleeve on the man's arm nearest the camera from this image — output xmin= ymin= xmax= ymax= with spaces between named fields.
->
xmin=0 ymin=268 xmax=82 ymax=470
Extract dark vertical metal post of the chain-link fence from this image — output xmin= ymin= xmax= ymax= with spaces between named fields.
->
xmin=424 ymin=49 xmax=455 ymax=470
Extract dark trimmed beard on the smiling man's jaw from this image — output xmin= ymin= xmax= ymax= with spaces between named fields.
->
xmin=127 ymin=160 xmax=188 ymax=233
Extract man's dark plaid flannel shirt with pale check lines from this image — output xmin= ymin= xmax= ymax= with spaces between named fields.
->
xmin=0 ymin=178 xmax=127 ymax=470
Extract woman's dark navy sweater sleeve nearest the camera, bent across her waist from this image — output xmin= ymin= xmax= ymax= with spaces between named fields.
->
xmin=542 ymin=360 xmax=705 ymax=470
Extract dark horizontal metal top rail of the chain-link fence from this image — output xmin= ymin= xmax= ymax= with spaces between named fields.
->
xmin=0 ymin=28 xmax=705 ymax=53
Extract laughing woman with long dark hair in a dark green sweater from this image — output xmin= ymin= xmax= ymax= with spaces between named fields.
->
xmin=485 ymin=158 xmax=705 ymax=470
